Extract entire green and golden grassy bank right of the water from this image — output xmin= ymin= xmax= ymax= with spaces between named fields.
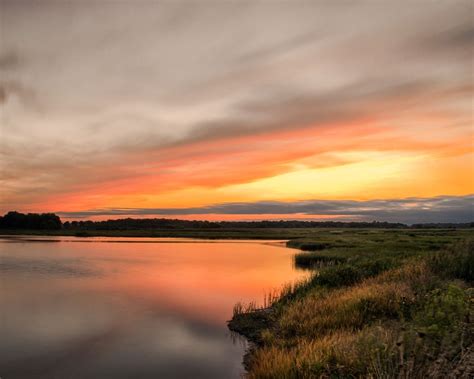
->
xmin=229 ymin=230 xmax=474 ymax=378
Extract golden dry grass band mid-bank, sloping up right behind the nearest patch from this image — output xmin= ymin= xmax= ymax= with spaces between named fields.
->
xmin=278 ymin=262 xmax=433 ymax=339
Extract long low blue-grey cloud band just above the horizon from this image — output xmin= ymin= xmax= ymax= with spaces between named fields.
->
xmin=58 ymin=194 xmax=474 ymax=224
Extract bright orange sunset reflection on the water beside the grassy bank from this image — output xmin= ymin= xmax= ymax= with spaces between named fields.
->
xmin=78 ymin=241 xmax=306 ymax=322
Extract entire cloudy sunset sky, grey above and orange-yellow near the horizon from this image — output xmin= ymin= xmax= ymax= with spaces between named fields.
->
xmin=0 ymin=0 xmax=474 ymax=222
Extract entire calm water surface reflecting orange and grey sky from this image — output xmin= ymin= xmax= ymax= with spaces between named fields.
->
xmin=0 ymin=237 xmax=306 ymax=379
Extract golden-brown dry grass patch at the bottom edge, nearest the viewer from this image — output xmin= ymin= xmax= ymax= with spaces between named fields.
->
xmin=249 ymin=327 xmax=397 ymax=378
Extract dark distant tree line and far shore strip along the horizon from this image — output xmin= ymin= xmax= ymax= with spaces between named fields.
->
xmin=0 ymin=212 xmax=474 ymax=239
